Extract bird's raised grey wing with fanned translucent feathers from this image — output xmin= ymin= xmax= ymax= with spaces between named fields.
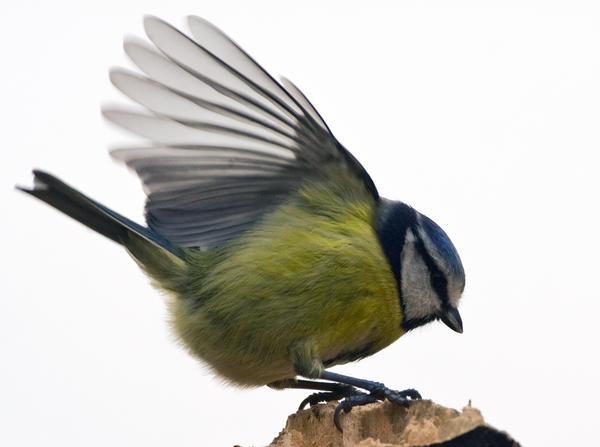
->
xmin=104 ymin=17 xmax=378 ymax=248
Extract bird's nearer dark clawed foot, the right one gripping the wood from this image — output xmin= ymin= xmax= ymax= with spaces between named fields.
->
xmin=333 ymin=382 xmax=421 ymax=431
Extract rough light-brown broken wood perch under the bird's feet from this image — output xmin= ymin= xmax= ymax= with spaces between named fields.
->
xmin=269 ymin=400 xmax=519 ymax=447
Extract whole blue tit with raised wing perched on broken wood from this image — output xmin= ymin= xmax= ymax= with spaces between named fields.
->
xmin=17 ymin=16 xmax=465 ymax=430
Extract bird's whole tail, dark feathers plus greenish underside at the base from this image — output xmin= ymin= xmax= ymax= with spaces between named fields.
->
xmin=17 ymin=170 xmax=185 ymax=291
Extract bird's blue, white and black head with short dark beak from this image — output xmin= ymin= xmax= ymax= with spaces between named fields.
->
xmin=377 ymin=201 xmax=465 ymax=333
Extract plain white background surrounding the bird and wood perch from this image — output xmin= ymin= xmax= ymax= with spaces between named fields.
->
xmin=0 ymin=0 xmax=600 ymax=447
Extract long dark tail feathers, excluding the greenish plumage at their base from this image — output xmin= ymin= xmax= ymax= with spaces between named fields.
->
xmin=17 ymin=170 xmax=183 ymax=258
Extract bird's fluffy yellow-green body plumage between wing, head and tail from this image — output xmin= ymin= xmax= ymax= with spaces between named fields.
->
xmin=172 ymin=180 xmax=403 ymax=386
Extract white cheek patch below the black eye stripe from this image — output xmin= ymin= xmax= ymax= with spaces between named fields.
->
xmin=401 ymin=230 xmax=441 ymax=319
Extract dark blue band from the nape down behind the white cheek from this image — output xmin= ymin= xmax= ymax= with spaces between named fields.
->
xmin=375 ymin=201 xmax=417 ymax=315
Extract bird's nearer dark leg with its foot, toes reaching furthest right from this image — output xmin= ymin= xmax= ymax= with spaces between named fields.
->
xmin=319 ymin=371 xmax=421 ymax=431
